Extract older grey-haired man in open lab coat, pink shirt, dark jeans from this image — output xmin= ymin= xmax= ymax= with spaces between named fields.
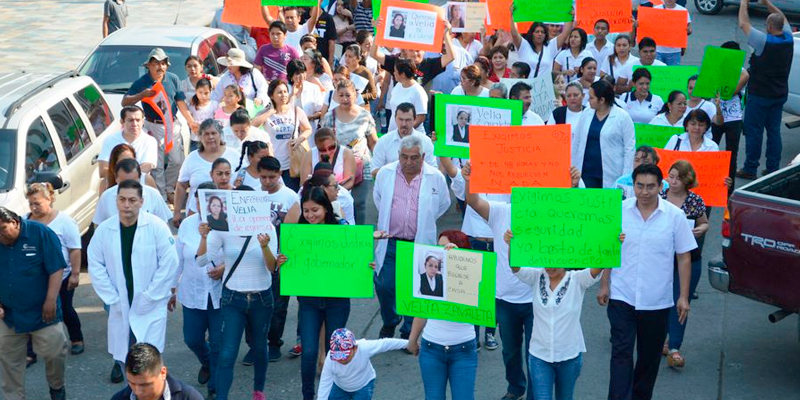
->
xmin=372 ymin=135 xmax=450 ymax=339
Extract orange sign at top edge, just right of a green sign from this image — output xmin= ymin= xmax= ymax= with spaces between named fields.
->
xmin=575 ymin=0 xmax=633 ymax=33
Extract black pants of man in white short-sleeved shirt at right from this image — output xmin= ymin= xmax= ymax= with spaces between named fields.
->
xmin=608 ymin=300 xmax=669 ymax=400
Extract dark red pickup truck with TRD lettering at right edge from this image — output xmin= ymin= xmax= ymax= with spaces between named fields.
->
xmin=708 ymin=164 xmax=800 ymax=329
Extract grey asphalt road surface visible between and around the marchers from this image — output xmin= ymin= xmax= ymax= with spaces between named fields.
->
xmin=6 ymin=1 xmax=800 ymax=400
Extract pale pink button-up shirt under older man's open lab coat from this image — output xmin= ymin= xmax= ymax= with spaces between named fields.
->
xmin=389 ymin=165 xmax=422 ymax=240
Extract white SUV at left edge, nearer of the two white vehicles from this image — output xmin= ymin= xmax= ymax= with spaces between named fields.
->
xmin=0 ymin=72 xmax=119 ymax=233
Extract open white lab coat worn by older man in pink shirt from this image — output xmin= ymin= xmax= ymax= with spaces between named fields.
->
xmin=372 ymin=161 xmax=450 ymax=273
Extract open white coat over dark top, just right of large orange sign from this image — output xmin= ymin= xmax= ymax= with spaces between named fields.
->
xmin=572 ymin=106 xmax=636 ymax=188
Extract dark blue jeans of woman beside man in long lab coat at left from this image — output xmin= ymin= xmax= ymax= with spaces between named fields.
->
xmin=183 ymin=296 xmax=222 ymax=391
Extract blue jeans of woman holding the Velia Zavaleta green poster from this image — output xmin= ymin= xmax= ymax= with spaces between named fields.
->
xmin=419 ymin=339 xmax=478 ymax=400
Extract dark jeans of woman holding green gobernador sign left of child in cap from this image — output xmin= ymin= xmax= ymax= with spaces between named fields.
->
xmin=297 ymin=297 xmax=350 ymax=400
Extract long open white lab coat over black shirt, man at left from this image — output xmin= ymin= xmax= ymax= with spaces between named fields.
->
xmin=88 ymin=212 xmax=178 ymax=361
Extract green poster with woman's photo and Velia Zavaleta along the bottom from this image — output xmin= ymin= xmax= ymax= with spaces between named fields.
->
xmin=396 ymin=241 xmax=497 ymax=326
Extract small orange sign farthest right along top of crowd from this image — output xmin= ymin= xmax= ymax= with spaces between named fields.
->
xmin=636 ymin=7 xmax=689 ymax=48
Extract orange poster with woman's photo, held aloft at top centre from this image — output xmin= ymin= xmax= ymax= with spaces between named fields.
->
xmin=375 ymin=0 xmax=444 ymax=53
